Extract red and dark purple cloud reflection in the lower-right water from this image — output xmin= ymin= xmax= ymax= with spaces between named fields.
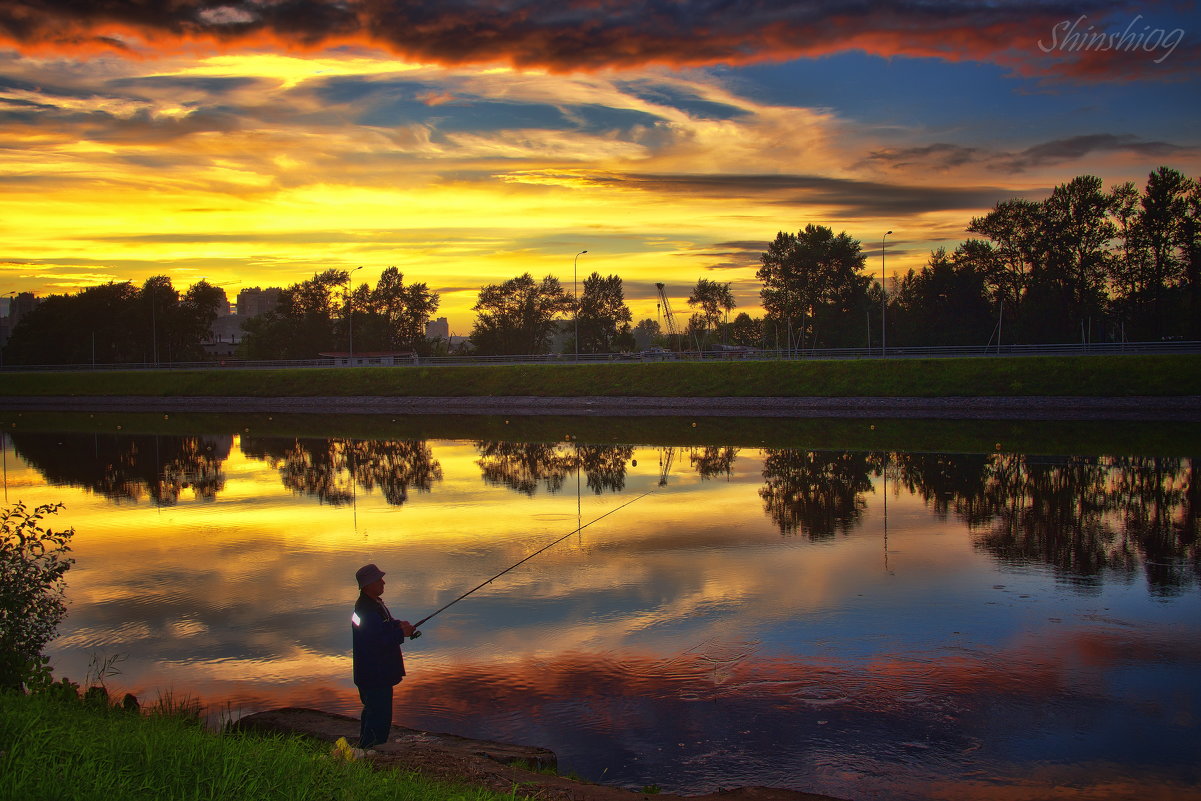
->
xmin=357 ymin=630 xmax=1191 ymax=797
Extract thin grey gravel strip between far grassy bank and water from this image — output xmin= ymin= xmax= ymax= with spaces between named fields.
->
xmin=0 ymin=395 xmax=1201 ymax=422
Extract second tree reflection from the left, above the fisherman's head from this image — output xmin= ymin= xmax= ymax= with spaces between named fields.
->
xmin=241 ymin=437 xmax=442 ymax=506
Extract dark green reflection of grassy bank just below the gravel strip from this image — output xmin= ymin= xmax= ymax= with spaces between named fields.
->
xmin=7 ymin=411 xmax=1201 ymax=456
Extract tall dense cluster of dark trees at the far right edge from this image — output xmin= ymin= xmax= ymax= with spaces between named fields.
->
xmin=890 ymin=167 xmax=1201 ymax=345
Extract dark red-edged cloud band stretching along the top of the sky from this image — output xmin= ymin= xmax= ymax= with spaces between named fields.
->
xmin=0 ymin=0 xmax=1187 ymax=80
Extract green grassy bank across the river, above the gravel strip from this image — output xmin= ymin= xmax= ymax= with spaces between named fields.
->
xmin=7 ymin=354 xmax=1201 ymax=397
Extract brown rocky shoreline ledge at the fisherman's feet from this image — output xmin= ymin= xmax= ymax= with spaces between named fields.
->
xmin=234 ymin=707 xmax=838 ymax=801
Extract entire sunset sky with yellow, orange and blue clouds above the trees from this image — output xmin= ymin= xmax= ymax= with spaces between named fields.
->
xmin=0 ymin=0 xmax=1201 ymax=334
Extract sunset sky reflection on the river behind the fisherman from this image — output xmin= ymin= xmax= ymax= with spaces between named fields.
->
xmin=10 ymin=429 xmax=1201 ymax=797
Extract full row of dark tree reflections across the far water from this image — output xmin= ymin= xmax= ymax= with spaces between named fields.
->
xmin=10 ymin=430 xmax=1201 ymax=596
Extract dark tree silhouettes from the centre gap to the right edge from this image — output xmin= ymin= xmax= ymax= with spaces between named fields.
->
xmin=461 ymin=167 xmax=1201 ymax=354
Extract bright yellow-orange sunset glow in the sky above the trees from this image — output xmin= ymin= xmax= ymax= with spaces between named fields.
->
xmin=0 ymin=43 xmax=1090 ymax=335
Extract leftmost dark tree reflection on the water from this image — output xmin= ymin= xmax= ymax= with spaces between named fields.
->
xmin=8 ymin=431 xmax=233 ymax=506
